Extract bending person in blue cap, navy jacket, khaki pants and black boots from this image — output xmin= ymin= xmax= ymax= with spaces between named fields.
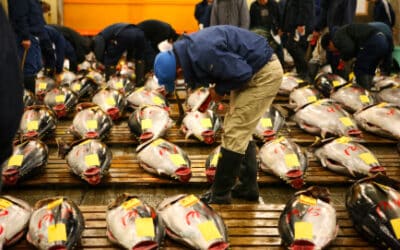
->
xmin=154 ymin=25 xmax=283 ymax=204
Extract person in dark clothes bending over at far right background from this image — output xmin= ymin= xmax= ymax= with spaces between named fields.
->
xmin=321 ymin=23 xmax=393 ymax=90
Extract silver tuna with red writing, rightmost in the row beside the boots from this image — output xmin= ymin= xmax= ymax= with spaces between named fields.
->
xmin=315 ymin=137 xmax=385 ymax=177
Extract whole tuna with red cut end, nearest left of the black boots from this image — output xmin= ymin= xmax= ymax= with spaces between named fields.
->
xmin=136 ymin=138 xmax=192 ymax=182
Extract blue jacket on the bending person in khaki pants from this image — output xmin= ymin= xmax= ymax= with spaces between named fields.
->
xmin=174 ymin=25 xmax=273 ymax=95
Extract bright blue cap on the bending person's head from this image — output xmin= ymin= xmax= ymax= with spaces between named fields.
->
xmin=154 ymin=51 xmax=176 ymax=93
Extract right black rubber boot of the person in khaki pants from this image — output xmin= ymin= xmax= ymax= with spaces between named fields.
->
xmin=232 ymin=141 xmax=260 ymax=201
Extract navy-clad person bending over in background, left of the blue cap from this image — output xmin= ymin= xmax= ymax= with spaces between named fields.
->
xmin=93 ymin=23 xmax=151 ymax=86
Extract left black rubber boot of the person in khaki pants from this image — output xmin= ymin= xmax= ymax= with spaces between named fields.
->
xmin=201 ymin=147 xmax=243 ymax=204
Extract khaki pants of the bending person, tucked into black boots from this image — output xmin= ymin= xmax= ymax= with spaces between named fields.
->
xmin=222 ymin=55 xmax=283 ymax=154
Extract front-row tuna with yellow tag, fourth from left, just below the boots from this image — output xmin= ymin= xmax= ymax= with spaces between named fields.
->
xmin=157 ymin=194 xmax=229 ymax=250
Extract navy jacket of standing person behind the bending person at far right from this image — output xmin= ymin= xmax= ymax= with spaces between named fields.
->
xmin=315 ymin=0 xmax=357 ymax=31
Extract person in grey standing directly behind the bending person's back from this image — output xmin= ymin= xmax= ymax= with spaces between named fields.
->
xmin=210 ymin=0 xmax=250 ymax=29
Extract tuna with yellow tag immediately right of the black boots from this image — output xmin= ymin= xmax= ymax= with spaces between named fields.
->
xmin=259 ymin=137 xmax=308 ymax=189
